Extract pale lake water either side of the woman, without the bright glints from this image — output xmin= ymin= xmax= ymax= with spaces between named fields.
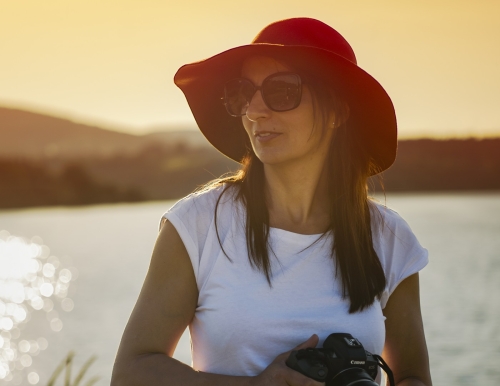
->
xmin=0 ymin=193 xmax=500 ymax=386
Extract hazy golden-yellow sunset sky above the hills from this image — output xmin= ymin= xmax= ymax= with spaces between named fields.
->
xmin=0 ymin=0 xmax=500 ymax=137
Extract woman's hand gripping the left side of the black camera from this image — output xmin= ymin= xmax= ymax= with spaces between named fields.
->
xmin=250 ymin=334 xmax=324 ymax=386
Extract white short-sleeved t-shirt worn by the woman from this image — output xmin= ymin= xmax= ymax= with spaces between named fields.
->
xmin=164 ymin=187 xmax=428 ymax=382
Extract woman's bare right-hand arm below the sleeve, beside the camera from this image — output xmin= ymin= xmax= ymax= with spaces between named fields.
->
xmin=382 ymin=273 xmax=432 ymax=386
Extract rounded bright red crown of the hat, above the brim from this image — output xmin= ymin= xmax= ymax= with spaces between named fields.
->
xmin=252 ymin=17 xmax=357 ymax=64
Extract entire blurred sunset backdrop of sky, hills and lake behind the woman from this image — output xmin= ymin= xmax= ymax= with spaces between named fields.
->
xmin=0 ymin=0 xmax=500 ymax=385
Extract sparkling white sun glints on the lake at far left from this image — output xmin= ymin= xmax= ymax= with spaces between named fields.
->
xmin=0 ymin=231 xmax=77 ymax=385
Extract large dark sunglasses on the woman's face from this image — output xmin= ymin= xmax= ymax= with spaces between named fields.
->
xmin=224 ymin=72 xmax=302 ymax=117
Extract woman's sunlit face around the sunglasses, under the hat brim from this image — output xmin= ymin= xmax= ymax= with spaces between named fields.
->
xmin=242 ymin=56 xmax=333 ymax=164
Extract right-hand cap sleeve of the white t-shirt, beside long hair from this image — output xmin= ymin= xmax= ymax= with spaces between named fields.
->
xmin=372 ymin=205 xmax=429 ymax=308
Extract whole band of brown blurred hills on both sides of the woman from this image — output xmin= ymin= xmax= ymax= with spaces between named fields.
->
xmin=0 ymin=108 xmax=500 ymax=208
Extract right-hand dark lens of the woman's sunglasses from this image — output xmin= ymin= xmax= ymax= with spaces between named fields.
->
xmin=262 ymin=74 xmax=301 ymax=111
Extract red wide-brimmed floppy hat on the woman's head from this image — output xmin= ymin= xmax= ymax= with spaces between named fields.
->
xmin=174 ymin=18 xmax=397 ymax=172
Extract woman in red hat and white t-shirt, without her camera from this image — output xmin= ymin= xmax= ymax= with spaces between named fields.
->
xmin=112 ymin=18 xmax=431 ymax=386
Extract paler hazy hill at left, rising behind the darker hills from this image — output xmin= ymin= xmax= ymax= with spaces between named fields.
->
xmin=0 ymin=107 xmax=208 ymax=159
